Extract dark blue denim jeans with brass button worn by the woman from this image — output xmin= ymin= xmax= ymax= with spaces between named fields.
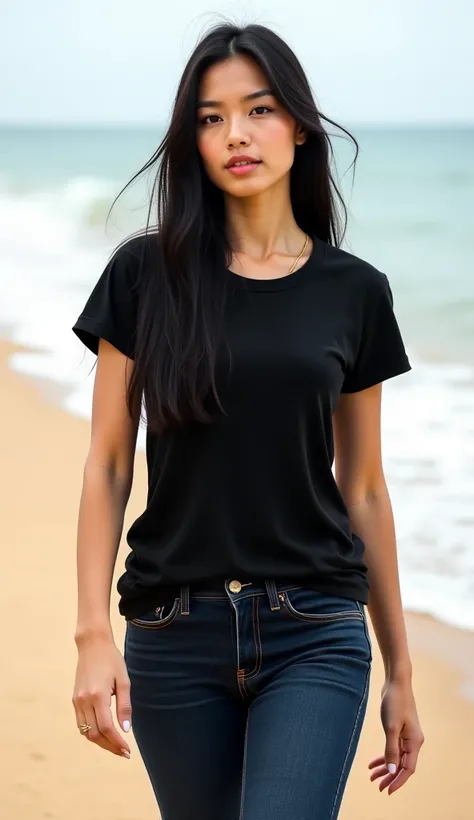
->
xmin=124 ymin=579 xmax=372 ymax=820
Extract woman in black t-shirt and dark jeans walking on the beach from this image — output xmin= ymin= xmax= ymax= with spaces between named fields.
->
xmin=73 ymin=17 xmax=423 ymax=820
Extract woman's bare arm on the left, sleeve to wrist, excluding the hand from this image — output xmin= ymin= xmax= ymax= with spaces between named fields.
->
xmin=74 ymin=339 xmax=139 ymax=646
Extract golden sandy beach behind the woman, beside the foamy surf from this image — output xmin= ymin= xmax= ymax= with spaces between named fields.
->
xmin=0 ymin=334 xmax=474 ymax=820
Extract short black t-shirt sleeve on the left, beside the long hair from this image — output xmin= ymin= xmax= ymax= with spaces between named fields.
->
xmin=72 ymin=244 xmax=140 ymax=359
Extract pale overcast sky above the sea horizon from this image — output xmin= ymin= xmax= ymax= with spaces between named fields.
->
xmin=0 ymin=0 xmax=474 ymax=124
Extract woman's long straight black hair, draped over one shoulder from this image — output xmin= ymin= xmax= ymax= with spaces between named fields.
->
xmin=105 ymin=22 xmax=358 ymax=432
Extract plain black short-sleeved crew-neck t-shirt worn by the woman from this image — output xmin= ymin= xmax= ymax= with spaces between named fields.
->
xmin=73 ymin=236 xmax=411 ymax=619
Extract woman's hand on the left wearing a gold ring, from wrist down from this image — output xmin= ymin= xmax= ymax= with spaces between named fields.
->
xmin=72 ymin=637 xmax=132 ymax=757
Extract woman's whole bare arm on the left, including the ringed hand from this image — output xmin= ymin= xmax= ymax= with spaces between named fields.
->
xmin=72 ymin=338 xmax=140 ymax=754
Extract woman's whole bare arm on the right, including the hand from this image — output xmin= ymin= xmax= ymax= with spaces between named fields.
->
xmin=333 ymin=383 xmax=424 ymax=794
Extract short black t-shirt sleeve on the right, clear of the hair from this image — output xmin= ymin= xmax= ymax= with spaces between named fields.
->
xmin=341 ymin=271 xmax=412 ymax=393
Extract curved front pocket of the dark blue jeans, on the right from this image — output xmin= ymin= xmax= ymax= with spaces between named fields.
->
xmin=279 ymin=587 xmax=364 ymax=624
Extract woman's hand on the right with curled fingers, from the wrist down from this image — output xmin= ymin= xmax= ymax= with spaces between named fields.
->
xmin=369 ymin=680 xmax=425 ymax=794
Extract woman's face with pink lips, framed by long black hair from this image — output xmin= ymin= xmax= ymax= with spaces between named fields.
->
xmin=197 ymin=54 xmax=305 ymax=197
